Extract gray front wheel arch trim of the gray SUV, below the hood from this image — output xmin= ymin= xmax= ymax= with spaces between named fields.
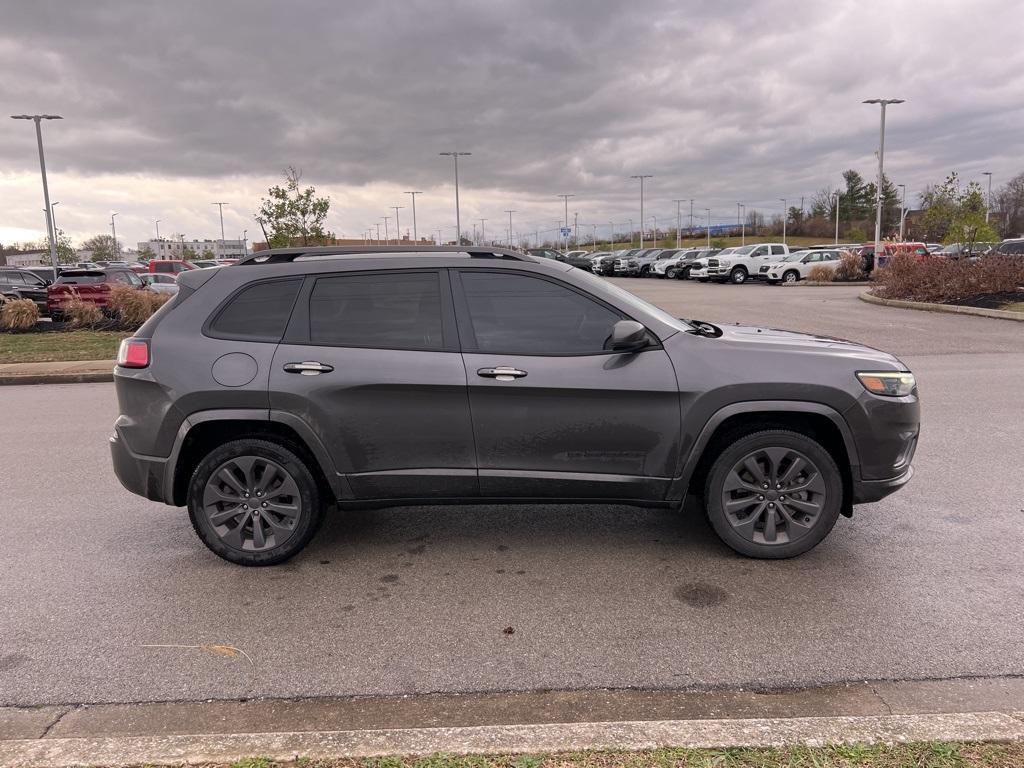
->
xmin=669 ymin=400 xmax=860 ymax=517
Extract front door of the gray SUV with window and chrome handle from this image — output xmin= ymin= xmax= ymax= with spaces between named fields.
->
xmin=452 ymin=268 xmax=680 ymax=500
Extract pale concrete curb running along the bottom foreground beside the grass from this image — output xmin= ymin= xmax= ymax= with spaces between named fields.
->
xmin=0 ymin=712 xmax=1024 ymax=768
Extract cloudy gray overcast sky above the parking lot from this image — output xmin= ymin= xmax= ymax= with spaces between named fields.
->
xmin=0 ymin=0 xmax=1024 ymax=247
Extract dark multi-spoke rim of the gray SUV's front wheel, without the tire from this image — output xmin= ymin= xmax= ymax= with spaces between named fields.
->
xmin=722 ymin=447 xmax=827 ymax=546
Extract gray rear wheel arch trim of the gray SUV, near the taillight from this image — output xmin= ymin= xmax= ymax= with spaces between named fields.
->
xmin=164 ymin=410 xmax=350 ymax=507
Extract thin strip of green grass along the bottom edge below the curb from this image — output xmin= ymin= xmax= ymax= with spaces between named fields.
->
xmin=222 ymin=741 xmax=1024 ymax=768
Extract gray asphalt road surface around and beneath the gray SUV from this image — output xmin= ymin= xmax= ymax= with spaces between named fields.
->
xmin=0 ymin=281 xmax=1024 ymax=705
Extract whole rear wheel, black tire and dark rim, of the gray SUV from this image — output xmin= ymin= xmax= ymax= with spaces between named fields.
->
xmin=187 ymin=438 xmax=324 ymax=565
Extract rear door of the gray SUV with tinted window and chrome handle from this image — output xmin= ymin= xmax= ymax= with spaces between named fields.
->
xmin=270 ymin=269 xmax=478 ymax=499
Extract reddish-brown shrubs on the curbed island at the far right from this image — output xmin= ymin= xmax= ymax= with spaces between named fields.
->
xmin=876 ymin=254 xmax=1024 ymax=303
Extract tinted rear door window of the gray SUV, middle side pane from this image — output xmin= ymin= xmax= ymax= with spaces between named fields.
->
xmin=309 ymin=272 xmax=443 ymax=349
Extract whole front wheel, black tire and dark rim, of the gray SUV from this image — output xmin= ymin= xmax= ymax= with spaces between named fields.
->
xmin=705 ymin=429 xmax=843 ymax=559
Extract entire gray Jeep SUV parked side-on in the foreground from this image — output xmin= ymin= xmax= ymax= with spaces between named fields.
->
xmin=111 ymin=247 xmax=920 ymax=565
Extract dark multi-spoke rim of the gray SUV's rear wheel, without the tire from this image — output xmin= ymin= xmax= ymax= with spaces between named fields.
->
xmin=203 ymin=456 xmax=302 ymax=552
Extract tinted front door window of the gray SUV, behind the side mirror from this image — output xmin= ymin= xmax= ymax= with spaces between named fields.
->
xmin=462 ymin=272 xmax=622 ymax=354
